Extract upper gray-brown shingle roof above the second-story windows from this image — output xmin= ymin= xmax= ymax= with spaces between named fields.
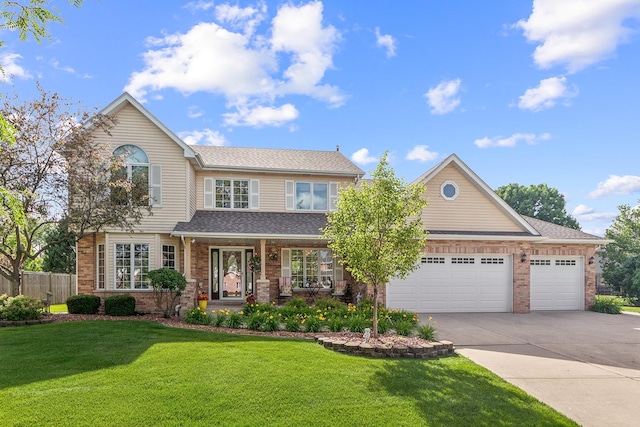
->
xmin=191 ymin=145 xmax=364 ymax=176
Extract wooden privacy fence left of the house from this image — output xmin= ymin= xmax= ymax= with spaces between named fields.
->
xmin=0 ymin=271 xmax=76 ymax=304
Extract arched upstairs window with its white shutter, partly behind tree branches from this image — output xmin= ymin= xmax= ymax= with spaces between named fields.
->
xmin=112 ymin=144 xmax=162 ymax=206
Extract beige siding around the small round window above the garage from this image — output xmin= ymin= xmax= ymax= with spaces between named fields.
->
xmin=422 ymin=164 xmax=525 ymax=232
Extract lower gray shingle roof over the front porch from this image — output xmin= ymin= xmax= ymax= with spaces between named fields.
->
xmin=173 ymin=211 xmax=327 ymax=236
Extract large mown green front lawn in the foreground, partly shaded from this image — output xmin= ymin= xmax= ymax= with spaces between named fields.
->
xmin=0 ymin=320 xmax=576 ymax=426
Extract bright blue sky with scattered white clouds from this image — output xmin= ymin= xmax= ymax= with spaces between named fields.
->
xmin=0 ymin=0 xmax=640 ymax=235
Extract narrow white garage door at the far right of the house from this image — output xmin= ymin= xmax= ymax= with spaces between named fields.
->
xmin=530 ymin=256 xmax=584 ymax=310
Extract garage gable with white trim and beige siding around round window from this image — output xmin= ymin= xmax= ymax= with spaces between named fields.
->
xmin=414 ymin=154 xmax=540 ymax=236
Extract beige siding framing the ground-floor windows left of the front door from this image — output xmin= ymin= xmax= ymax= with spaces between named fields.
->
xmin=104 ymin=233 xmax=182 ymax=290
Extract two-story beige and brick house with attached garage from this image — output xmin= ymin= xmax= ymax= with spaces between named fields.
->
xmin=77 ymin=93 xmax=606 ymax=313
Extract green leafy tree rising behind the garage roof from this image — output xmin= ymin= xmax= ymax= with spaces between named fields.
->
xmin=496 ymin=183 xmax=580 ymax=230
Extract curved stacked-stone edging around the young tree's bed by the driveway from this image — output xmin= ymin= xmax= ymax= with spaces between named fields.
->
xmin=315 ymin=335 xmax=455 ymax=359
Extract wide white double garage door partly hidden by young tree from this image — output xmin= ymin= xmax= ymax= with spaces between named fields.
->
xmin=387 ymin=255 xmax=513 ymax=313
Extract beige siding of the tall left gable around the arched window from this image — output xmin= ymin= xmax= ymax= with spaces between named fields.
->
xmin=96 ymin=105 xmax=190 ymax=233
